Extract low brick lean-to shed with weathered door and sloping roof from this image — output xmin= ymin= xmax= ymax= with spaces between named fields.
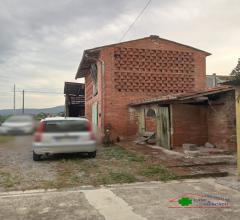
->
xmin=130 ymin=86 xmax=236 ymax=151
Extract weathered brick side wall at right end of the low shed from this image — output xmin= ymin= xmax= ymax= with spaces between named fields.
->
xmin=208 ymin=91 xmax=237 ymax=151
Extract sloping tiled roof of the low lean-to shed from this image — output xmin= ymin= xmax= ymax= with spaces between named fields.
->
xmin=129 ymin=86 xmax=234 ymax=106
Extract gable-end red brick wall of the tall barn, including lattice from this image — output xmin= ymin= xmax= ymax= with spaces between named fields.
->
xmin=86 ymin=38 xmax=206 ymax=138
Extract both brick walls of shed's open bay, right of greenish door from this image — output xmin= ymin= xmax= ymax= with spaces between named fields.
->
xmin=171 ymin=91 xmax=236 ymax=151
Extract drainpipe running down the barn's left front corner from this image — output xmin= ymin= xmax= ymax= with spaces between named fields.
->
xmin=85 ymin=54 xmax=105 ymax=138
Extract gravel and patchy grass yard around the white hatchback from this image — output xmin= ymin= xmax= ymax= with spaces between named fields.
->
xmin=0 ymin=136 xmax=176 ymax=191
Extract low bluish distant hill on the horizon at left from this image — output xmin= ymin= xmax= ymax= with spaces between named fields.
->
xmin=0 ymin=106 xmax=64 ymax=115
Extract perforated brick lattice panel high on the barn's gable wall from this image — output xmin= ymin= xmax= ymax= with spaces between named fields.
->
xmin=114 ymin=47 xmax=195 ymax=93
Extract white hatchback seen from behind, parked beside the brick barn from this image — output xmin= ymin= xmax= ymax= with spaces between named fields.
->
xmin=33 ymin=117 xmax=97 ymax=161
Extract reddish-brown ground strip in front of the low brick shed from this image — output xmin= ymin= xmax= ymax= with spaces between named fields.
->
xmin=118 ymin=141 xmax=237 ymax=179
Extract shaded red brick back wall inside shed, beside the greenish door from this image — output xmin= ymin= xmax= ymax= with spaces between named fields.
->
xmin=171 ymin=104 xmax=208 ymax=148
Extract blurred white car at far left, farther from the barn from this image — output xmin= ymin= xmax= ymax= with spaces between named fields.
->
xmin=0 ymin=115 xmax=35 ymax=134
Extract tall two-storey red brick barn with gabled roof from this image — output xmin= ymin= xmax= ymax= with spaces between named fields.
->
xmin=75 ymin=35 xmax=236 ymax=150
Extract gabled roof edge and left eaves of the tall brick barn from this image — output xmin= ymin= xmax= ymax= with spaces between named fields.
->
xmin=75 ymin=35 xmax=211 ymax=79
